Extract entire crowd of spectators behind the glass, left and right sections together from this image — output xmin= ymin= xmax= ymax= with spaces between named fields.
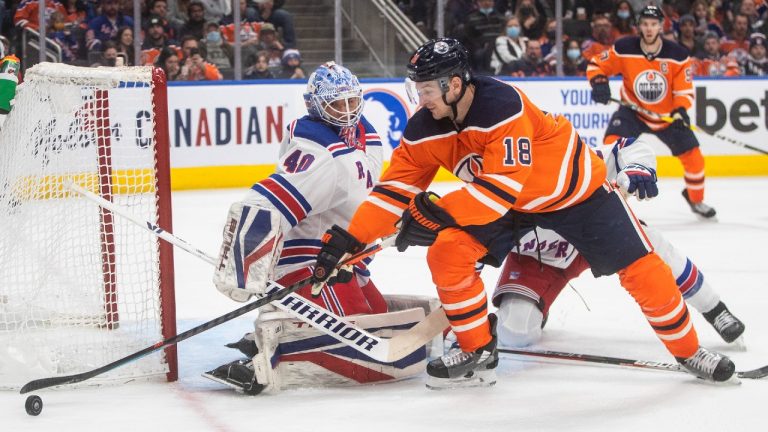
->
xmin=0 ymin=0 xmax=768 ymax=81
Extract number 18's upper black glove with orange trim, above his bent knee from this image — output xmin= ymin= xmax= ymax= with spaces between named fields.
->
xmin=395 ymin=192 xmax=456 ymax=252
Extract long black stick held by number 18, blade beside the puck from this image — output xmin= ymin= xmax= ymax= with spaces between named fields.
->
xmin=19 ymin=244 xmax=382 ymax=394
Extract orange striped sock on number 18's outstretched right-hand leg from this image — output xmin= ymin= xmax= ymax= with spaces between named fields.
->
xmin=619 ymin=252 xmax=699 ymax=358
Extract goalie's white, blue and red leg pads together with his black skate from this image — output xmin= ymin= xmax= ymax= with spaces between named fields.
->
xmin=203 ymin=295 xmax=443 ymax=395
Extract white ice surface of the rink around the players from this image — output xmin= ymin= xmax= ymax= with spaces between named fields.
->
xmin=0 ymin=175 xmax=768 ymax=432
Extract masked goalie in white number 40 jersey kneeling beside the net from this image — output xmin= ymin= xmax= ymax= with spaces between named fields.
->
xmin=204 ymin=62 xmax=436 ymax=394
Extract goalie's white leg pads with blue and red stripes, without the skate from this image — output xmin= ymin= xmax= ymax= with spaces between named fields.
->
xmin=254 ymin=308 xmax=426 ymax=391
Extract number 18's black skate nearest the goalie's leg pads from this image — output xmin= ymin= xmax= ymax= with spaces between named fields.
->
xmin=427 ymin=314 xmax=499 ymax=390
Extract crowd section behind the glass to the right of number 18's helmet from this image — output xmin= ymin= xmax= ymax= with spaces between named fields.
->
xmin=398 ymin=0 xmax=768 ymax=76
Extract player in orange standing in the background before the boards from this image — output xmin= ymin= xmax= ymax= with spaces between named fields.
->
xmin=587 ymin=6 xmax=716 ymax=218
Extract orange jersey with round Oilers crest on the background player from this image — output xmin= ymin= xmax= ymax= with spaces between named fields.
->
xmin=587 ymin=36 xmax=694 ymax=130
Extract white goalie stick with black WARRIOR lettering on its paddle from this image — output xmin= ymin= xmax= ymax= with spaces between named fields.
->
xmin=65 ymin=181 xmax=449 ymax=363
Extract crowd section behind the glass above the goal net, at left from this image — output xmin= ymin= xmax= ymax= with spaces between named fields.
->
xmin=0 ymin=0 xmax=305 ymax=81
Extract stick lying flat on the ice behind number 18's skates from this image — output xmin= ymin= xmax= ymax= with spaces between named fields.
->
xmin=499 ymin=348 xmax=768 ymax=379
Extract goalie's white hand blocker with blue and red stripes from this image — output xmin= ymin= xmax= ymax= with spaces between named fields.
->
xmin=213 ymin=202 xmax=283 ymax=302
